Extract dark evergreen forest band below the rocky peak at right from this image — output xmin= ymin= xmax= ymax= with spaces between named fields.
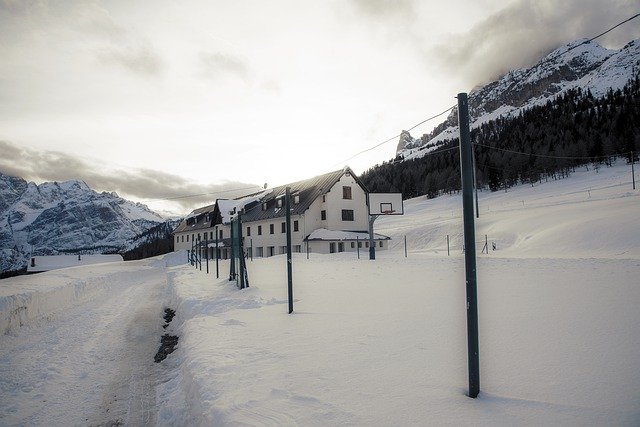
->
xmin=361 ymin=74 xmax=640 ymax=199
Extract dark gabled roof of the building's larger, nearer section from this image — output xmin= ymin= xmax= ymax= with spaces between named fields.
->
xmin=242 ymin=166 xmax=367 ymax=222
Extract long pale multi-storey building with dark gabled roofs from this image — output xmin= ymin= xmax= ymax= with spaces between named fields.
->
xmin=173 ymin=167 xmax=390 ymax=259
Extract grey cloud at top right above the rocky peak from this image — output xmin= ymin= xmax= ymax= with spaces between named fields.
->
xmin=428 ymin=0 xmax=640 ymax=86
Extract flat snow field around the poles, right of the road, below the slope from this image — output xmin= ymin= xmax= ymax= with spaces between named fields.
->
xmin=157 ymin=252 xmax=640 ymax=425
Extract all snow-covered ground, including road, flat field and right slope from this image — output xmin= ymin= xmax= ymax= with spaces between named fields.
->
xmin=0 ymin=163 xmax=640 ymax=426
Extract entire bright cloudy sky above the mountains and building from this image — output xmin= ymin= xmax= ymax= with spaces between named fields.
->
xmin=0 ymin=0 xmax=640 ymax=215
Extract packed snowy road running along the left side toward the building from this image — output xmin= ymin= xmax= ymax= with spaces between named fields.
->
xmin=0 ymin=263 xmax=166 ymax=425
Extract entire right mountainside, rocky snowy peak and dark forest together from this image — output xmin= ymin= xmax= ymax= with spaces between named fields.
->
xmin=362 ymin=37 xmax=640 ymax=198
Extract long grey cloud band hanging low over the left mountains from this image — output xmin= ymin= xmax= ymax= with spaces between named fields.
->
xmin=0 ymin=141 xmax=260 ymax=211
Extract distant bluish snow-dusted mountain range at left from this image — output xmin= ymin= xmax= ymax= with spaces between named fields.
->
xmin=0 ymin=173 xmax=165 ymax=271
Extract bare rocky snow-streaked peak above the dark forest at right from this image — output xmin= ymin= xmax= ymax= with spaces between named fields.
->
xmin=396 ymin=39 xmax=640 ymax=160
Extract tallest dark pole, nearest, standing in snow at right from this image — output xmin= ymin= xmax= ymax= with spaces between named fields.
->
xmin=458 ymin=93 xmax=480 ymax=398
